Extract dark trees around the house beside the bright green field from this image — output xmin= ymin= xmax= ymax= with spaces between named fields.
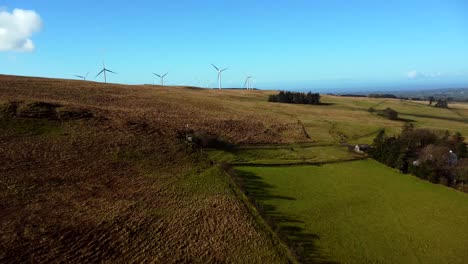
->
xmin=370 ymin=123 xmax=468 ymax=188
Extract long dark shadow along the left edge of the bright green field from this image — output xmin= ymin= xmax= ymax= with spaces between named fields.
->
xmin=230 ymin=169 xmax=337 ymax=263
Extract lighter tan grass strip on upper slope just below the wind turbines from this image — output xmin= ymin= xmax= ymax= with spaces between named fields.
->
xmin=0 ymin=76 xmax=307 ymax=143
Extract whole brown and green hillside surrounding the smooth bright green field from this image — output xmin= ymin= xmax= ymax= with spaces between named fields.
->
xmin=0 ymin=75 xmax=468 ymax=263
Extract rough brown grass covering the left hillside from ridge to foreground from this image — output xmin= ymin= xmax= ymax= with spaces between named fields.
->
xmin=0 ymin=76 xmax=296 ymax=263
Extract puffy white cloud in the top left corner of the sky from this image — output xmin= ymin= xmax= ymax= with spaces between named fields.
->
xmin=0 ymin=9 xmax=42 ymax=51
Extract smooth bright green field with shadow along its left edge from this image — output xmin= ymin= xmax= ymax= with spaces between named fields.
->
xmin=236 ymin=160 xmax=468 ymax=263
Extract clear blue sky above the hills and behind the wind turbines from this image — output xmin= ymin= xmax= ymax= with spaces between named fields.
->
xmin=0 ymin=0 xmax=468 ymax=92
